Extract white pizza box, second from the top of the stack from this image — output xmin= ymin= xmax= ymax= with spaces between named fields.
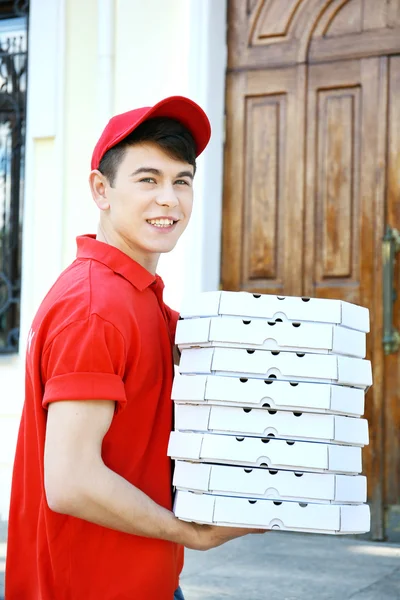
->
xmin=175 ymin=317 xmax=366 ymax=358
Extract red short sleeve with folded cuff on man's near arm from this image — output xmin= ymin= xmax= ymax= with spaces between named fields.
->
xmin=42 ymin=315 xmax=126 ymax=409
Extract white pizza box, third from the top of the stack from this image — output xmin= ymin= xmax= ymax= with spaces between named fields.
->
xmin=179 ymin=348 xmax=372 ymax=389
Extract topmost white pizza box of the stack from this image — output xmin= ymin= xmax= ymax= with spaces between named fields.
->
xmin=181 ymin=291 xmax=369 ymax=333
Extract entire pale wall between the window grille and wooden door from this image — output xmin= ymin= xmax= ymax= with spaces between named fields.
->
xmin=0 ymin=0 xmax=226 ymax=519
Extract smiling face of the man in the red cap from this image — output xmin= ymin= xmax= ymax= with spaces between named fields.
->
xmin=103 ymin=142 xmax=193 ymax=262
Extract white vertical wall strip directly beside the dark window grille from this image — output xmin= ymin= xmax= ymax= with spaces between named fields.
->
xmin=0 ymin=0 xmax=63 ymax=519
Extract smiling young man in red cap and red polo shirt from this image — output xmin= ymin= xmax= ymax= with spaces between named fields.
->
xmin=6 ymin=97 xmax=262 ymax=600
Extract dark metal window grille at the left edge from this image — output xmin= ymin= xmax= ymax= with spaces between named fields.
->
xmin=0 ymin=0 xmax=28 ymax=354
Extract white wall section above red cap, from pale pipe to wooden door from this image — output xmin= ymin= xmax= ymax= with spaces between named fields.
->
xmin=114 ymin=0 xmax=226 ymax=309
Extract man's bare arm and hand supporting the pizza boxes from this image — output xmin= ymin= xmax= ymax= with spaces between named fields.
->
xmin=44 ymin=400 xmax=258 ymax=550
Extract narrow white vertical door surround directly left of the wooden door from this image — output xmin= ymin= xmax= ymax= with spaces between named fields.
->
xmin=176 ymin=0 xmax=227 ymax=307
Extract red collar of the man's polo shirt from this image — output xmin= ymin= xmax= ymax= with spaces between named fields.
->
xmin=76 ymin=234 xmax=164 ymax=292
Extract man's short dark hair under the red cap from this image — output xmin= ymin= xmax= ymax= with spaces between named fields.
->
xmin=99 ymin=117 xmax=196 ymax=186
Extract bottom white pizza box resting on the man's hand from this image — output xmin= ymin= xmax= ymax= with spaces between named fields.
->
xmin=174 ymin=491 xmax=370 ymax=534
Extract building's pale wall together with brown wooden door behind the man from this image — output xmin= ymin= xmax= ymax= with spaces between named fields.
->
xmin=0 ymin=0 xmax=400 ymax=539
